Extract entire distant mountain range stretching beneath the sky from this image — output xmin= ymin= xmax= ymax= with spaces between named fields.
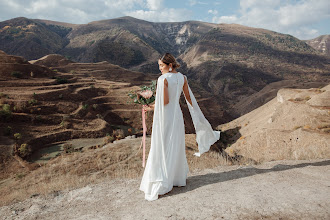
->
xmin=0 ymin=17 xmax=330 ymax=117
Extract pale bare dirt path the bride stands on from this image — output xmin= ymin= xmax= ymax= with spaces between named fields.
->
xmin=0 ymin=160 xmax=330 ymax=220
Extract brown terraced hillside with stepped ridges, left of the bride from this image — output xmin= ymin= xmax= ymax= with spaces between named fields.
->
xmin=0 ymin=51 xmax=230 ymax=199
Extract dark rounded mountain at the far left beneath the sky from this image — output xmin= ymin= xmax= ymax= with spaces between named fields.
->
xmin=0 ymin=17 xmax=71 ymax=60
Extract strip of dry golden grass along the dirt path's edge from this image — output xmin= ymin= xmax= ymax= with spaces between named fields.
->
xmin=0 ymin=134 xmax=231 ymax=206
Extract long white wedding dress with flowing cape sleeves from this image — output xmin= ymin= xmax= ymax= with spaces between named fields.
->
xmin=140 ymin=73 xmax=220 ymax=201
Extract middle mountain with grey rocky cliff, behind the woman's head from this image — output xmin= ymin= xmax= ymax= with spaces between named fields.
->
xmin=61 ymin=17 xmax=219 ymax=72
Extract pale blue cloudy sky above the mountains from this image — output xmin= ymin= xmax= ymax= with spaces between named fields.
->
xmin=0 ymin=0 xmax=330 ymax=40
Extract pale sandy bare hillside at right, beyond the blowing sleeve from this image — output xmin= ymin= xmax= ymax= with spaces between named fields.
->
xmin=217 ymin=85 xmax=330 ymax=162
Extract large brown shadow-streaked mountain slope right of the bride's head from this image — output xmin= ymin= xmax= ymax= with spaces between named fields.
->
xmin=180 ymin=24 xmax=330 ymax=116
